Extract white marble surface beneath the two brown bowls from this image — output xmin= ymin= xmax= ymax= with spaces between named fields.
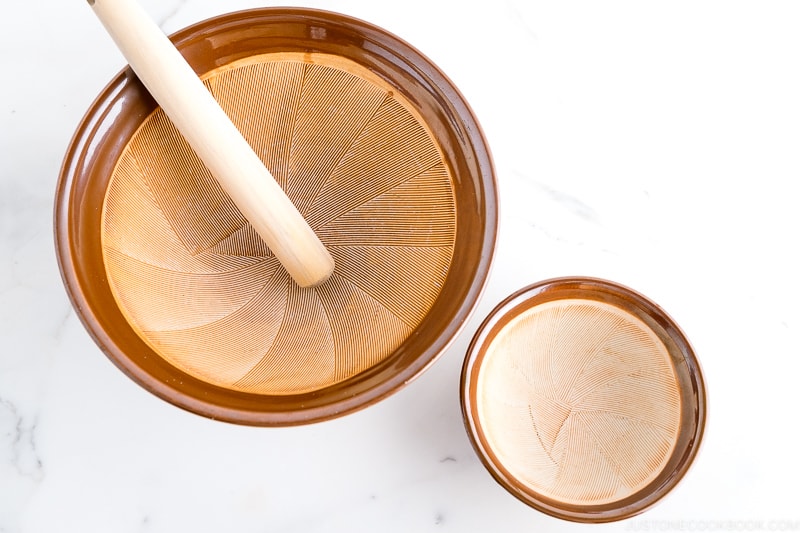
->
xmin=0 ymin=0 xmax=800 ymax=533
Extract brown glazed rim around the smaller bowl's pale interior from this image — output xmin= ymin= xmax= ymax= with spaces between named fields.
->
xmin=461 ymin=277 xmax=707 ymax=523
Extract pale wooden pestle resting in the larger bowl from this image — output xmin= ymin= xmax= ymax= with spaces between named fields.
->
xmin=88 ymin=0 xmax=334 ymax=287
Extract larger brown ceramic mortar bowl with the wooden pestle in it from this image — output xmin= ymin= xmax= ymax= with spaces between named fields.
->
xmin=55 ymin=8 xmax=497 ymax=425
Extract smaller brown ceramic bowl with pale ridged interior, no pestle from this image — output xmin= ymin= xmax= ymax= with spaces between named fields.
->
xmin=461 ymin=278 xmax=706 ymax=522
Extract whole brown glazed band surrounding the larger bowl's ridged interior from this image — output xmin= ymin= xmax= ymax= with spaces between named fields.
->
xmin=54 ymin=8 xmax=498 ymax=426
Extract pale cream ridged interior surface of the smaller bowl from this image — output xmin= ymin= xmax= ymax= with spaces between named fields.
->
xmin=477 ymin=299 xmax=681 ymax=505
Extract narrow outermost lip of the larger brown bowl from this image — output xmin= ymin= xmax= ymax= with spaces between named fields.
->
xmin=53 ymin=7 xmax=499 ymax=426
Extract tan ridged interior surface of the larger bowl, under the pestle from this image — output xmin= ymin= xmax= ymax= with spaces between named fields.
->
xmin=102 ymin=53 xmax=456 ymax=395
